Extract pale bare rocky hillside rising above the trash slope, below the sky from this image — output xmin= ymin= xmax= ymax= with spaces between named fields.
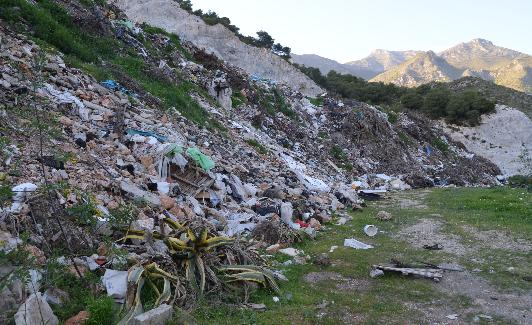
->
xmin=111 ymin=0 xmax=323 ymax=96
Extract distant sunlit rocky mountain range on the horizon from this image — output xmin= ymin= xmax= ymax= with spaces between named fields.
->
xmin=292 ymin=38 xmax=532 ymax=93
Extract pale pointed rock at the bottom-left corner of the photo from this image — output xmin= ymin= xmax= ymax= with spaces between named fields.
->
xmin=15 ymin=292 xmax=59 ymax=325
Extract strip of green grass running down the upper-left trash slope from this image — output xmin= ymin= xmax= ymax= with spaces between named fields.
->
xmin=0 ymin=0 xmax=219 ymax=127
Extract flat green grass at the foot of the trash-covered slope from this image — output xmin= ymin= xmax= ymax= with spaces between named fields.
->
xmin=193 ymin=188 xmax=532 ymax=324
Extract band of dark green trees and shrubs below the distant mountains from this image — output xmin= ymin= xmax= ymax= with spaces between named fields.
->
xmin=298 ymin=66 xmax=495 ymax=125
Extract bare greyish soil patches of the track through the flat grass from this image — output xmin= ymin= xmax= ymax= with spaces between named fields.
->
xmin=398 ymin=214 xmax=532 ymax=324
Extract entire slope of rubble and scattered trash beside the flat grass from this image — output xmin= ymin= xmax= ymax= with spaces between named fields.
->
xmin=0 ymin=2 xmax=499 ymax=323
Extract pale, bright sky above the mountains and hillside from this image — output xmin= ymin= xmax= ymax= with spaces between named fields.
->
xmin=192 ymin=0 xmax=532 ymax=63
